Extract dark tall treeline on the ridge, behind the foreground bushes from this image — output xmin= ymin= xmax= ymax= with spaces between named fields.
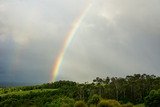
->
xmin=41 ymin=74 xmax=160 ymax=104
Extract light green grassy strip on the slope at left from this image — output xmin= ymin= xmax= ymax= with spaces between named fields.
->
xmin=0 ymin=89 xmax=57 ymax=96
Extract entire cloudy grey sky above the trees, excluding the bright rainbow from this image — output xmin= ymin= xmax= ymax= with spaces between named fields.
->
xmin=0 ymin=0 xmax=160 ymax=83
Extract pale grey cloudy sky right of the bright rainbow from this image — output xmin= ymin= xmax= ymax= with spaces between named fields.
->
xmin=61 ymin=0 xmax=160 ymax=81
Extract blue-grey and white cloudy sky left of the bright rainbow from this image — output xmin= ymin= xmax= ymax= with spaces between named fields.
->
xmin=0 ymin=0 xmax=89 ymax=82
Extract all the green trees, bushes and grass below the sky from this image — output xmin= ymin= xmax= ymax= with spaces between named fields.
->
xmin=0 ymin=74 xmax=160 ymax=107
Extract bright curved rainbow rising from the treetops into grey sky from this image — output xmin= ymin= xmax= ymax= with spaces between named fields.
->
xmin=51 ymin=1 xmax=92 ymax=82
